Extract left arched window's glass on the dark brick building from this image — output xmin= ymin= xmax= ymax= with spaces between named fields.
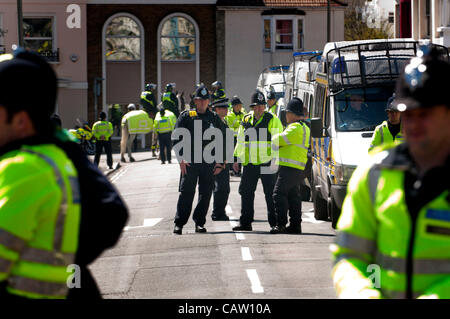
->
xmin=105 ymin=16 xmax=141 ymax=61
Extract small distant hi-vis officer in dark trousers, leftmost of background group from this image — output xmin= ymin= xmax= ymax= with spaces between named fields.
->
xmin=92 ymin=112 xmax=114 ymax=169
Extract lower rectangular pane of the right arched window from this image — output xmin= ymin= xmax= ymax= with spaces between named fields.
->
xmin=161 ymin=37 xmax=195 ymax=61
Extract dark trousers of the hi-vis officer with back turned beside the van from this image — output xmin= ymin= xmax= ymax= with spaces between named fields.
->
xmin=273 ymin=166 xmax=305 ymax=227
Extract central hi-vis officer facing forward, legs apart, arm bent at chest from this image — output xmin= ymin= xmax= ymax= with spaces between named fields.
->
xmin=233 ymin=91 xmax=283 ymax=231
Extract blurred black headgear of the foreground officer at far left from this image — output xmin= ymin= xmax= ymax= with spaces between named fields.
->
xmin=0 ymin=49 xmax=57 ymax=122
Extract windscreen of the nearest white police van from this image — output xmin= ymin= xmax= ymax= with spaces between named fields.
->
xmin=334 ymin=86 xmax=394 ymax=131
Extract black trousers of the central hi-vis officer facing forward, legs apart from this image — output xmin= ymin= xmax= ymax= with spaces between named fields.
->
xmin=239 ymin=164 xmax=276 ymax=227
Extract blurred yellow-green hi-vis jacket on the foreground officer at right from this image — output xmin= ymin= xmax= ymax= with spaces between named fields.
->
xmin=331 ymin=151 xmax=450 ymax=298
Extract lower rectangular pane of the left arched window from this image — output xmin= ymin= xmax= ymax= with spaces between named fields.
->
xmin=106 ymin=38 xmax=141 ymax=61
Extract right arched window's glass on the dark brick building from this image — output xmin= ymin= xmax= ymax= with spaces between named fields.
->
xmin=161 ymin=16 xmax=196 ymax=61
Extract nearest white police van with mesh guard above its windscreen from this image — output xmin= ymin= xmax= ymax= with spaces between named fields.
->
xmin=306 ymin=39 xmax=446 ymax=228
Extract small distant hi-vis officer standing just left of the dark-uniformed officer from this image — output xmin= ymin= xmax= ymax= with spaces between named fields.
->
xmin=154 ymin=107 xmax=177 ymax=164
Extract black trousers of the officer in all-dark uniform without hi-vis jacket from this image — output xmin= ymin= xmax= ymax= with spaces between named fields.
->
xmin=174 ymin=163 xmax=214 ymax=227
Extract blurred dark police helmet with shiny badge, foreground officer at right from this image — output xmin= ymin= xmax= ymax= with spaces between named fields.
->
xmin=393 ymin=45 xmax=450 ymax=112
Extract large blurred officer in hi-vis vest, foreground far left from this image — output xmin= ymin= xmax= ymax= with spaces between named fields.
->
xmin=0 ymin=51 xmax=80 ymax=300
